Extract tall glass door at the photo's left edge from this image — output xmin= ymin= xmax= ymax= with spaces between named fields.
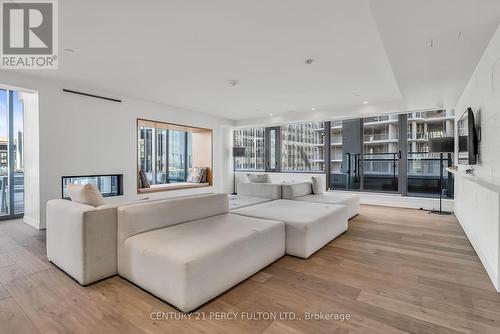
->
xmin=0 ymin=89 xmax=24 ymax=219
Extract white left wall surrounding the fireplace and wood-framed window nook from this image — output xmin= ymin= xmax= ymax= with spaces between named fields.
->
xmin=0 ymin=71 xmax=232 ymax=228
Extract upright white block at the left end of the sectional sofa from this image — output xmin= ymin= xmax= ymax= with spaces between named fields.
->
xmin=47 ymin=199 xmax=121 ymax=285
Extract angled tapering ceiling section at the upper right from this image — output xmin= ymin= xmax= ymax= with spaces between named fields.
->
xmin=369 ymin=0 xmax=500 ymax=108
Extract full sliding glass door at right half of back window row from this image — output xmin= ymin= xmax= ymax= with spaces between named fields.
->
xmin=330 ymin=110 xmax=454 ymax=198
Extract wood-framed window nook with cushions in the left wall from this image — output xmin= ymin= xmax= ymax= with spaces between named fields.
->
xmin=137 ymin=120 xmax=212 ymax=192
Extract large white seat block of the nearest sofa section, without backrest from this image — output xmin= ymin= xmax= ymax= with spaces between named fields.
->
xmin=118 ymin=213 xmax=285 ymax=312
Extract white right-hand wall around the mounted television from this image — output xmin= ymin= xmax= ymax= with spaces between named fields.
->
xmin=455 ymin=23 xmax=500 ymax=291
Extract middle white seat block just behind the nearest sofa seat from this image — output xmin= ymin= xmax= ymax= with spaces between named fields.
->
xmin=231 ymin=200 xmax=347 ymax=258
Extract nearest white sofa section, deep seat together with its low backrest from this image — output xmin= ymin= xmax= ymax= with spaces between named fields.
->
xmin=114 ymin=194 xmax=285 ymax=312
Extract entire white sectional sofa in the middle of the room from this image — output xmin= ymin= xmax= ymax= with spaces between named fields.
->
xmin=47 ymin=176 xmax=352 ymax=311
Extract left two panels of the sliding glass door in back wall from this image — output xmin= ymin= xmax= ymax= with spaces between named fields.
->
xmin=330 ymin=115 xmax=405 ymax=193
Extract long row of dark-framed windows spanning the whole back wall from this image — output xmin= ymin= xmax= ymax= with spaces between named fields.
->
xmin=234 ymin=110 xmax=454 ymax=197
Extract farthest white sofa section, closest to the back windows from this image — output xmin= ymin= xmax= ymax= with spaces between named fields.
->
xmin=281 ymin=182 xmax=359 ymax=219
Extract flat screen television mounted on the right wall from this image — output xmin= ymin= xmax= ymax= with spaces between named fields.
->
xmin=458 ymin=108 xmax=478 ymax=165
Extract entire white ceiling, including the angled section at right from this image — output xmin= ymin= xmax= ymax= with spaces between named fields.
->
xmin=10 ymin=0 xmax=500 ymax=120
